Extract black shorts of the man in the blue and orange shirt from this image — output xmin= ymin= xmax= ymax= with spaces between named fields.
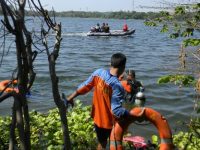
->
xmin=94 ymin=124 xmax=112 ymax=143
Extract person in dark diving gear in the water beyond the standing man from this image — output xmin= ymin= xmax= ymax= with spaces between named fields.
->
xmin=121 ymin=70 xmax=144 ymax=103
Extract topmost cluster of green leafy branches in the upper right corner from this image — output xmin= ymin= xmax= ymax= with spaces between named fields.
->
xmin=145 ymin=3 xmax=200 ymax=47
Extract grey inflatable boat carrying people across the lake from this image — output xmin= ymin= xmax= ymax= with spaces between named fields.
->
xmin=87 ymin=29 xmax=135 ymax=36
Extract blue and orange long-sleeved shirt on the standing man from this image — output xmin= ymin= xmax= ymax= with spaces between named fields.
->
xmin=77 ymin=69 xmax=128 ymax=129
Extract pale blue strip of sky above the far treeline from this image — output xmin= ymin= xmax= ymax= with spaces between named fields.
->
xmin=40 ymin=0 xmax=199 ymax=12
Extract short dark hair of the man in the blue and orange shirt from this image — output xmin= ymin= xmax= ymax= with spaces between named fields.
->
xmin=111 ymin=53 xmax=126 ymax=68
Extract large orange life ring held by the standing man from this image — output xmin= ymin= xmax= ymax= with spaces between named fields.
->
xmin=110 ymin=107 xmax=174 ymax=150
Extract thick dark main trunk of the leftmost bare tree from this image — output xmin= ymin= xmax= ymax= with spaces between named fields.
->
xmin=15 ymin=19 xmax=31 ymax=149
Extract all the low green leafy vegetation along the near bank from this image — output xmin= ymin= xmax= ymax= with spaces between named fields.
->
xmin=0 ymin=100 xmax=200 ymax=150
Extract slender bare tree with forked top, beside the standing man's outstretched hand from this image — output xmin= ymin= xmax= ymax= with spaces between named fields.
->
xmin=35 ymin=0 xmax=71 ymax=150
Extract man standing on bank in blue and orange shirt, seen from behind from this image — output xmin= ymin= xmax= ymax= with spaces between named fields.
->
xmin=67 ymin=53 xmax=132 ymax=150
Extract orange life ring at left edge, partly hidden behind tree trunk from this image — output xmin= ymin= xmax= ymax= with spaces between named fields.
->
xmin=0 ymin=80 xmax=19 ymax=93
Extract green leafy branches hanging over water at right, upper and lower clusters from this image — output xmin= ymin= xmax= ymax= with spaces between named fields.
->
xmin=144 ymin=3 xmax=200 ymax=106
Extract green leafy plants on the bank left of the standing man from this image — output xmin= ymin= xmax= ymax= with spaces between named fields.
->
xmin=0 ymin=100 xmax=97 ymax=150
